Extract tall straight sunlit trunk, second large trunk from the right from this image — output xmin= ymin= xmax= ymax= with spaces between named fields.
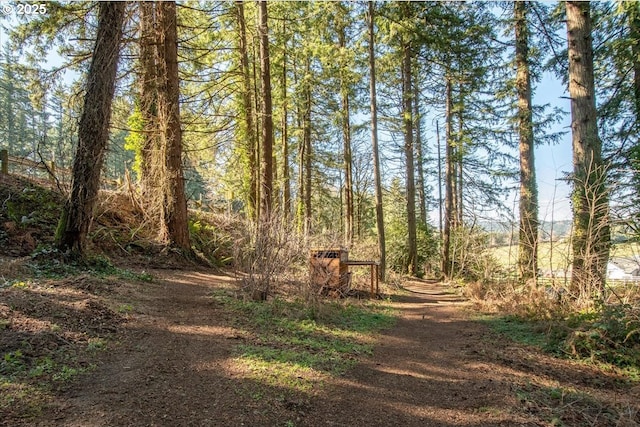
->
xmin=514 ymin=1 xmax=538 ymax=285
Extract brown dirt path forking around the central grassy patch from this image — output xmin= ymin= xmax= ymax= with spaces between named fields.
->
xmin=37 ymin=271 xmax=633 ymax=427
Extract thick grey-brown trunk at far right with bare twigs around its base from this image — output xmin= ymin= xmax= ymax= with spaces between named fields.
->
xmin=566 ymin=1 xmax=610 ymax=298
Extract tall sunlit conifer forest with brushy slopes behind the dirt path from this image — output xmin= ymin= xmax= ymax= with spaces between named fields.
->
xmin=0 ymin=0 xmax=640 ymax=425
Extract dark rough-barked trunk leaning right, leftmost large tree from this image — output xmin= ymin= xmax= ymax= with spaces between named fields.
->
xmin=56 ymin=2 xmax=125 ymax=256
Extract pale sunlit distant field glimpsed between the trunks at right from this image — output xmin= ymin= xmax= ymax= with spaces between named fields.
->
xmin=489 ymin=240 xmax=640 ymax=270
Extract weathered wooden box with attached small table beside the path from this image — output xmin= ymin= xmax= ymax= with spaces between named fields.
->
xmin=309 ymin=248 xmax=379 ymax=298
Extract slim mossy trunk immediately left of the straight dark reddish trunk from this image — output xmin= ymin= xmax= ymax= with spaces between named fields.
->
xmin=235 ymin=1 xmax=258 ymax=220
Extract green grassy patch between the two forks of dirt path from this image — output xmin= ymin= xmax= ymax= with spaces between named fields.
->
xmin=214 ymin=295 xmax=395 ymax=391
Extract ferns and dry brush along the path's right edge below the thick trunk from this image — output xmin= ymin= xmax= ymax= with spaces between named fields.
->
xmin=467 ymin=284 xmax=640 ymax=380
